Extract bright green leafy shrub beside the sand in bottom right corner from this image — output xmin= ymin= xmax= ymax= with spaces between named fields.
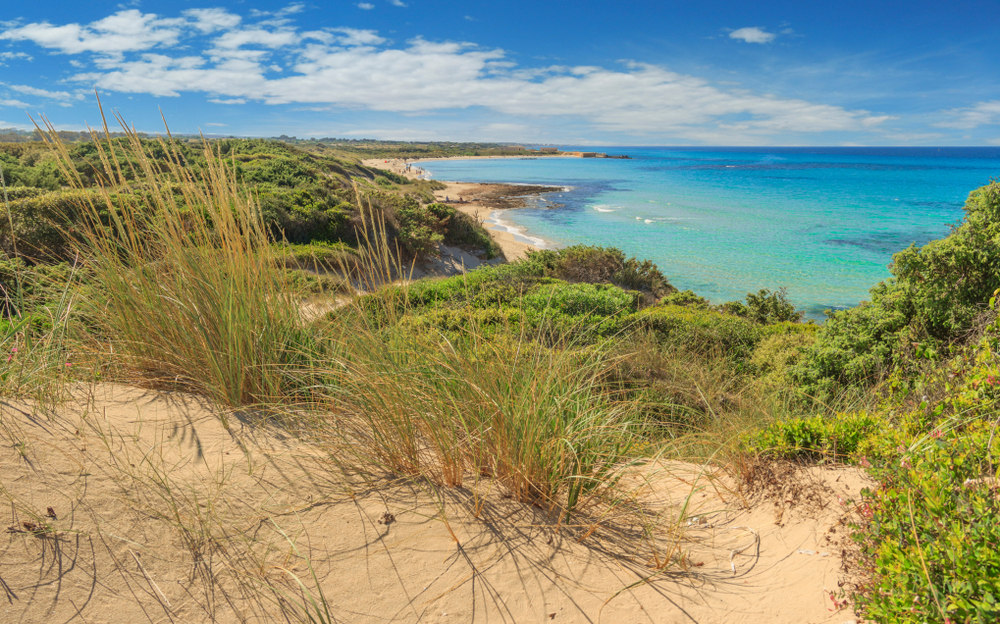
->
xmin=855 ymin=429 xmax=1000 ymax=624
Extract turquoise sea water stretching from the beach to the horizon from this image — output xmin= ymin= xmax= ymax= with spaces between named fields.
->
xmin=421 ymin=147 xmax=1000 ymax=318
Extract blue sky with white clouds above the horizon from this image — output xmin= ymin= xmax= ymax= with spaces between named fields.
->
xmin=0 ymin=0 xmax=1000 ymax=146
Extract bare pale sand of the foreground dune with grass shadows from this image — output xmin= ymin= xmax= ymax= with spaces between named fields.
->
xmin=0 ymin=384 xmax=870 ymax=624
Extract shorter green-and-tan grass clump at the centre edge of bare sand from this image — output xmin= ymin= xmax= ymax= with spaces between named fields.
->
xmin=319 ymin=325 xmax=640 ymax=520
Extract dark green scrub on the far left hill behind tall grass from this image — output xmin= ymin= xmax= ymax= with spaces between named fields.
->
xmin=0 ymin=137 xmax=499 ymax=261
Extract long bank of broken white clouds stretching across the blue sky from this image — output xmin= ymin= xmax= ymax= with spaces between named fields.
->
xmin=0 ymin=5 xmax=891 ymax=144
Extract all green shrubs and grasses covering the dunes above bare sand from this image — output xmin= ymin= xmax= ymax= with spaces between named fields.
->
xmin=0 ymin=118 xmax=1000 ymax=622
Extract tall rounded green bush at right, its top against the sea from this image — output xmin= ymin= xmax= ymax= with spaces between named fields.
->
xmin=795 ymin=182 xmax=1000 ymax=395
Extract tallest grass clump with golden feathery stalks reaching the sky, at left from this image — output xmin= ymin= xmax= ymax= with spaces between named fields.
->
xmin=36 ymin=111 xmax=305 ymax=406
